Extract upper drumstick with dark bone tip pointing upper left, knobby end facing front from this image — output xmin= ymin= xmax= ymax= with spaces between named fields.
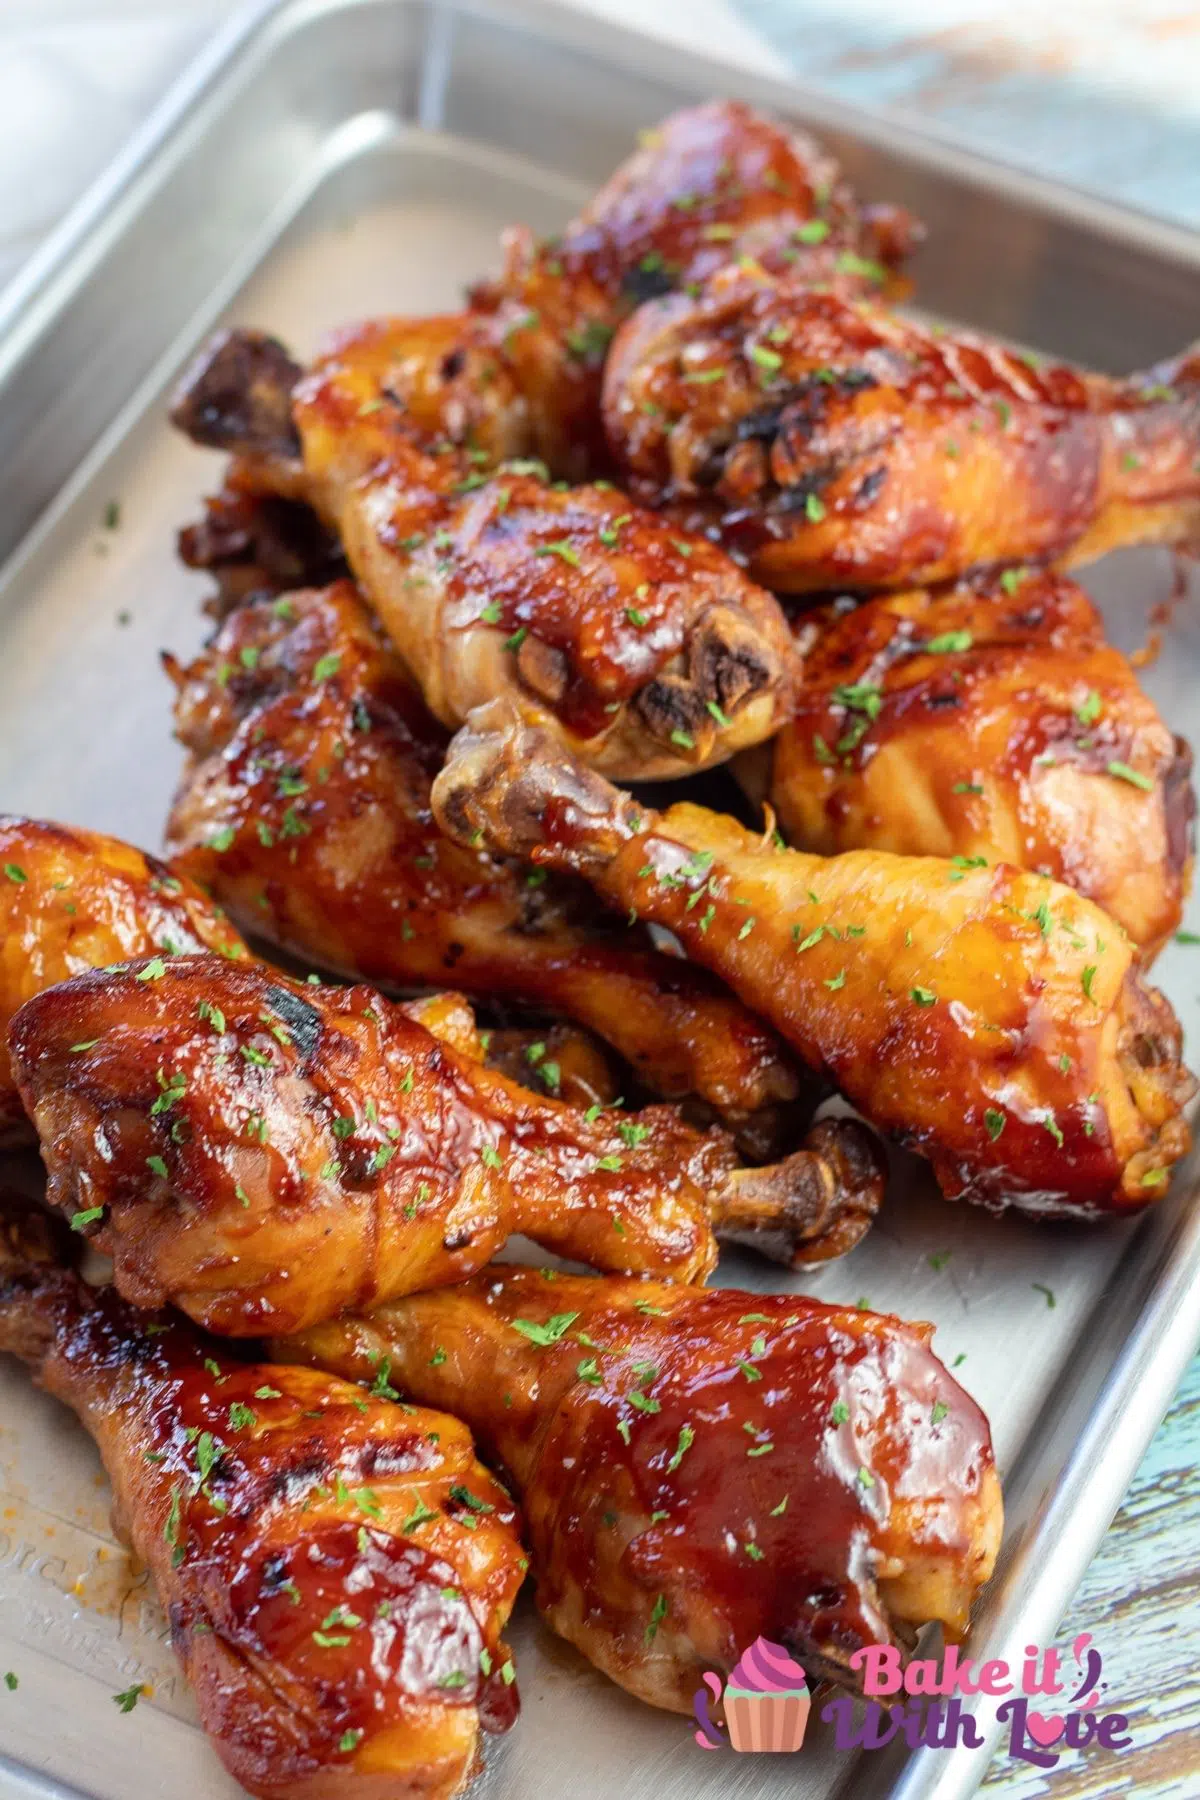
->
xmin=175 ymin=338 xmax=802 ymax=779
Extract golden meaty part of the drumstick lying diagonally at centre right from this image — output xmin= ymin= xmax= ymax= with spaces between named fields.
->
xmin=586 ymin=808 xmax=1187 ymax=1213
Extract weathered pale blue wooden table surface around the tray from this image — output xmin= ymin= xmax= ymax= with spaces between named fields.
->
xmin=0 ymin=0 xmax=1200 ymax=1800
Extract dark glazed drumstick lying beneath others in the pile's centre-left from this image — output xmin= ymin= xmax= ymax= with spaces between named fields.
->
xmin=159 ymin=581 xmax=797 ymax=1121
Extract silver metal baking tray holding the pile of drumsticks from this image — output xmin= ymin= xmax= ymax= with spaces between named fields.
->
xmin=0 ymin=0 xmax=1200 ymax=1800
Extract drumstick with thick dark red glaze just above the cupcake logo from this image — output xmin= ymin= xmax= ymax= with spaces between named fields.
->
xmin=279 ymin=1269 xmax=1000 ymax=1712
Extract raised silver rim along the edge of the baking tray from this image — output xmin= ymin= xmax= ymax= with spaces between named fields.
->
xmin=0 ymin=0 xmax=1200 ymax=1800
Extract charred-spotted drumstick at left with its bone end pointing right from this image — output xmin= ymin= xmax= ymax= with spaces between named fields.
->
xmin=9 ymin=958 xmax=882 ymax=1337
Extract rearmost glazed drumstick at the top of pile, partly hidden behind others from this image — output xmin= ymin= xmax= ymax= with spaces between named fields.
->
xmin=169 ymin=103 xmax=919 ymax=481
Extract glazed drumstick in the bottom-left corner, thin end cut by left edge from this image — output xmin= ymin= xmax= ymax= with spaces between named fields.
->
xmin=0 ymin=1210 xmax=525 ymax=1800
